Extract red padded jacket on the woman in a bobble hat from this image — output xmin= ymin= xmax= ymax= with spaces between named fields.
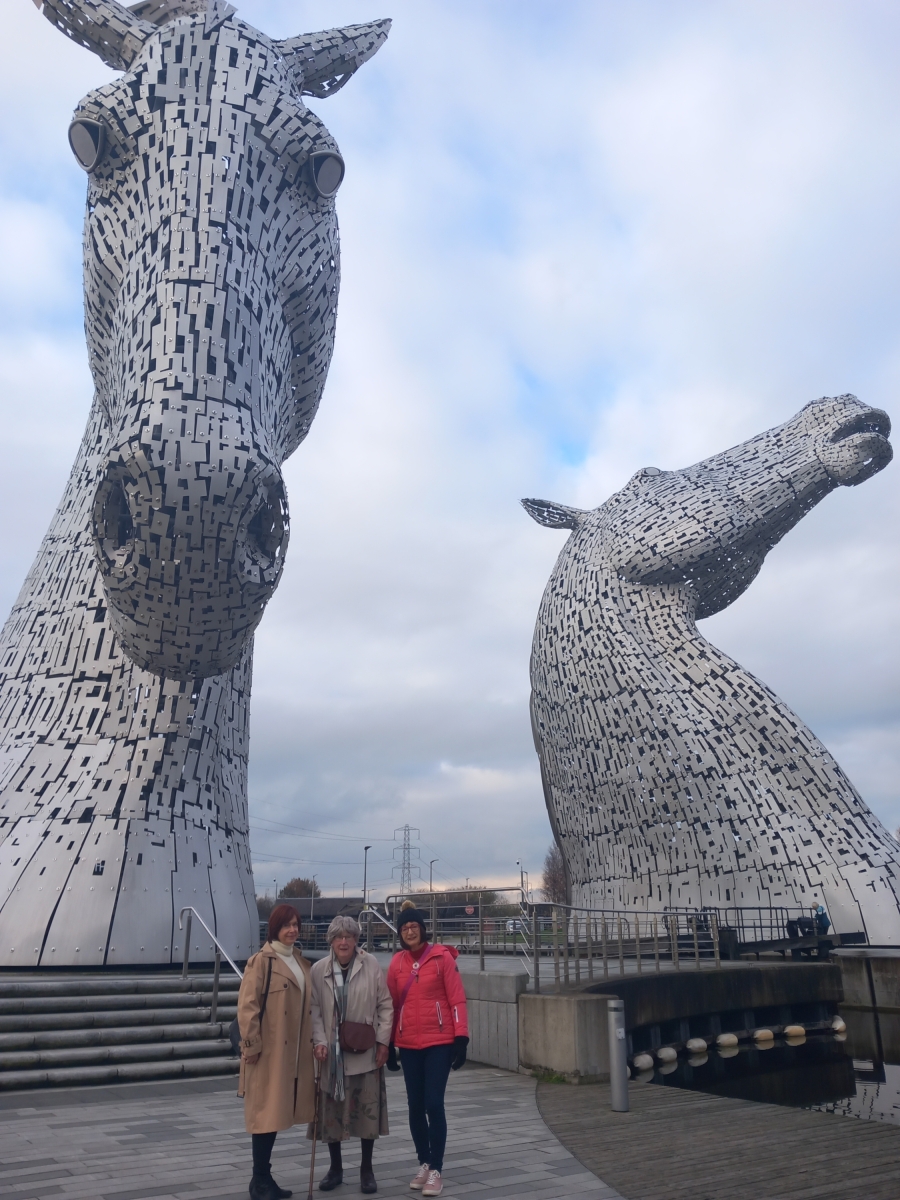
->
xmin=388 ymin=944 xmax=469 ymax=1050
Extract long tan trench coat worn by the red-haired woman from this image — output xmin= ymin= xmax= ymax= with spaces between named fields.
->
xmin=238 ymin=942 xmax=316 ymax=1133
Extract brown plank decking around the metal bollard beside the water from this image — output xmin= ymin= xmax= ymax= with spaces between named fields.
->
xmin=538 ymin=1082 xmax=900 ymax=1200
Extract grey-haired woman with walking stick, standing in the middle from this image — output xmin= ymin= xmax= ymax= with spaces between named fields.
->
xmin=307 ymin=917 xmax=394 ymax=1193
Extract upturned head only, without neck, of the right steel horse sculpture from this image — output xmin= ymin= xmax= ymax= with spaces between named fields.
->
xmin=522 ymin=396 xmax=893 ymax=619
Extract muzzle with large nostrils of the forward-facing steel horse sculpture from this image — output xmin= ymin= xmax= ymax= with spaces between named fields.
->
xmin=92 ymin=436 xmax=288 ymax=678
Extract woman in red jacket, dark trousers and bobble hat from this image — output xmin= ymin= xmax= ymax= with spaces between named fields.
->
xmin=388 ymin=900 xmax=469 ymax=1196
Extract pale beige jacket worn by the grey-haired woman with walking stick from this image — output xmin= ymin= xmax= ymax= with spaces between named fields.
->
xmin=312 ymin=949 xmax=394 ymax=1075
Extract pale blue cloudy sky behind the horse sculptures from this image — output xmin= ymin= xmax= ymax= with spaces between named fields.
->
xmin=0 ymin=0 xmax=900 ymax=894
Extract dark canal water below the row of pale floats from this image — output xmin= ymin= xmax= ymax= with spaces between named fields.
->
xmin=637 ymin=1009 xmax=900 ymax=1126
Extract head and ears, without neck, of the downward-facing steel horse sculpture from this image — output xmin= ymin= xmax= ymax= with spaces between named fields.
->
xmin=35 ymin=0 xmax=390 ymax=679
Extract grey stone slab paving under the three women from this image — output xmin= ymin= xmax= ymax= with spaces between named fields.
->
xmin=0 ymin=1064 xmax=622 ymax=1200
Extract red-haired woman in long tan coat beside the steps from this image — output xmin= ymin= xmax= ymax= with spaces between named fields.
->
xmin=238 ymin=904 xmax=316 ymax=1200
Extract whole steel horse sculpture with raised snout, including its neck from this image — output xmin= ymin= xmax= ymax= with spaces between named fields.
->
xmin=522 ymin=396 xmax=900 ymax=944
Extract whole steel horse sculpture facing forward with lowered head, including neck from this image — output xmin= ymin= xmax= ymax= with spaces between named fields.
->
xmin=0 ymin=0 xmax=390 ymax=966
